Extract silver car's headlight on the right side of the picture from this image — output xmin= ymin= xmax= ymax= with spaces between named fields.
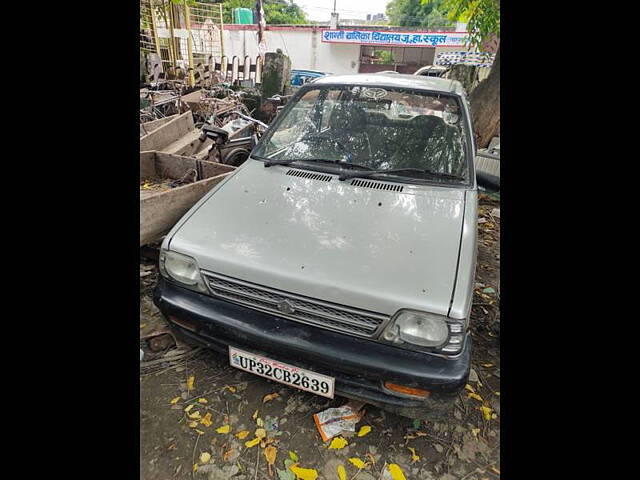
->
xmin=382 ymin=310 xmax=449 ymax=347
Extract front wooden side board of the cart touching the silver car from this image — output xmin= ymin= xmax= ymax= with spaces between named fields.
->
xmin=140 ymin=172 xmax=231 ymax=246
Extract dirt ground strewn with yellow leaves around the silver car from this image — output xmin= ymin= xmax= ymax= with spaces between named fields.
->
xmin=140 ymin=194 xmax=500 ymax=480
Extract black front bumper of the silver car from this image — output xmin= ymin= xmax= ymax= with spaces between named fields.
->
xmin=154 ymin=279 xmax=471 ymax=419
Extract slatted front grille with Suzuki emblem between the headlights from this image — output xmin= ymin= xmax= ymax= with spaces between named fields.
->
xmin=202 ymin=271 xmax=389 ymax=337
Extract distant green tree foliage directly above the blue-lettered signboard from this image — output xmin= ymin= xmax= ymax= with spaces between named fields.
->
xmin=387 ymin=0 xmax=455 ymax=30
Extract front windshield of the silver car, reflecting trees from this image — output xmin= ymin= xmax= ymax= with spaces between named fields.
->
xmin=254 ymin=85 xmax=469 ymax=183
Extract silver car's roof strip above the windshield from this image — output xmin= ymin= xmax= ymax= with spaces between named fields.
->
xmin=313 ymin=73 xmax=464 ymax=95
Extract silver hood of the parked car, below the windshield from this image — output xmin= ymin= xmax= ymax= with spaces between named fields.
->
xmin=169 ymin=160 xmax=465 ymax=315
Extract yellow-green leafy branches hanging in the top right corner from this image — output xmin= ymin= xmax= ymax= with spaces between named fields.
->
xmin=430 ymin=0 xmax=500 ymax=46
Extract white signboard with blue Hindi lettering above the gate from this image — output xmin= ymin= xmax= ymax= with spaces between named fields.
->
xmin=322 ymin=30 xmax=469 ymax=47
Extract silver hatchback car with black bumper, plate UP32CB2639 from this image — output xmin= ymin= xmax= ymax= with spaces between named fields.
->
xmin=154 ymin=74 xmax=477 ymax=418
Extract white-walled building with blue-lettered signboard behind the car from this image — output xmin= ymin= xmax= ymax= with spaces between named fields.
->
xmin=224 ymin=21 xmax=476 ymax=74
